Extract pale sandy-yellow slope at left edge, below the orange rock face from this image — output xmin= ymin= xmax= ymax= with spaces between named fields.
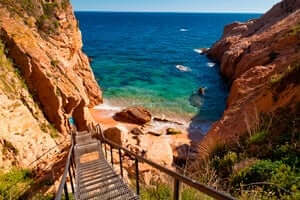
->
xmin=0 ymin=41 xmax=63 ymax=170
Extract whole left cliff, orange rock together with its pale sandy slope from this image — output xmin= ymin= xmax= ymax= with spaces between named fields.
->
xmin=0 ymin=0 xmax=102 ymax=167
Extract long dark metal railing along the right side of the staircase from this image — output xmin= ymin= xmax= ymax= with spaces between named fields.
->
xmin=91 ymin=125 xmax=235 ymax=200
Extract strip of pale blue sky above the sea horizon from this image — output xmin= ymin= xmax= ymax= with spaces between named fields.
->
xmin=71 ymin=0 xmax=280 ymax=13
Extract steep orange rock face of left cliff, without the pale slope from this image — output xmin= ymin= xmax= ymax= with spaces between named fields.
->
xmin=0 ymin=0 xmax=102 ymax=133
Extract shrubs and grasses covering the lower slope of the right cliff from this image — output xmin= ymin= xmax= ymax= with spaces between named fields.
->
xmin=193 ymin=104 xmax=300 ymax=199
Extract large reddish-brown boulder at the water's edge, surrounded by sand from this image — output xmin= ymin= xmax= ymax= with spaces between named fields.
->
xmin=114 ymin=106 xmax=152 ymax=125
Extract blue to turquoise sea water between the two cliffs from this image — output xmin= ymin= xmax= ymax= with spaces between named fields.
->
xmin=76 ymin=12 xmax=259 ymax=121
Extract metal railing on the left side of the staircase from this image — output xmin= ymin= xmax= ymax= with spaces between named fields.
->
xmin=55 ymin=135 xmax=75 ymax=200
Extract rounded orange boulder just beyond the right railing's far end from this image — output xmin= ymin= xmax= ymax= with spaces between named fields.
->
xmin=103 ymin=127 xmax=128 ymax=145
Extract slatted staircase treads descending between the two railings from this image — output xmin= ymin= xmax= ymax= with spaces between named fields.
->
xmin=74 ymin=132 xmax=139 ymax=200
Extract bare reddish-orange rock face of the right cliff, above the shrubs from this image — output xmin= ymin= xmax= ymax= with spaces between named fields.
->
xmin=200 ymin=0 xmax=300 ymax=156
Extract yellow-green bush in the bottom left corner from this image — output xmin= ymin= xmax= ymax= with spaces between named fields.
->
xmin=0 ymin=168 xmax=33 ymax=200
